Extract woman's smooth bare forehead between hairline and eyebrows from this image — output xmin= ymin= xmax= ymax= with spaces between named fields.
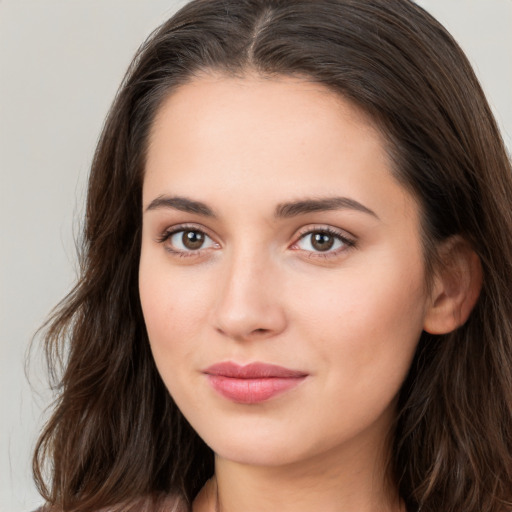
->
xmin=144 ymin=74 xmax=412 ymax=221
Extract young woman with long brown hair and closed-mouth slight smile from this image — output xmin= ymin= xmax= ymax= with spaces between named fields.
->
xmin=34 ymin=0 xmax=512 ymax=512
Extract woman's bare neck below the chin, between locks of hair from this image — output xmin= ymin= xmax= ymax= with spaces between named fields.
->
xmin=194 ymin=434 xmax=404 ymax=512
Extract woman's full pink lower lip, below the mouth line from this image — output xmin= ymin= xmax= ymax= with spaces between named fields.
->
xmin=207 ymin=375 xmax=306 ymax=404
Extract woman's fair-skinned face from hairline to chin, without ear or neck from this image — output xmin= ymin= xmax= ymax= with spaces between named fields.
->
xmin=139 ymin=74 xmax=429 ymax=466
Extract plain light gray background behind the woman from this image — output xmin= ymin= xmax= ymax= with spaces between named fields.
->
xmin=0 ymin=0 xmax=512 ymax=512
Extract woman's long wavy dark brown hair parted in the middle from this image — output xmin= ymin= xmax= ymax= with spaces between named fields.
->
xmin=34 ymin=0 xmax=512 ymax=512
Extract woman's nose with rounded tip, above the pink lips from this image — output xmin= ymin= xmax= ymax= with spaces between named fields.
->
xmin=213 ymin=249 xmax=287 ymax=341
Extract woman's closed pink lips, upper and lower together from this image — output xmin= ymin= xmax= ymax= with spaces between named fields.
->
xmin=203 ymin=362 xmax=308 ymax=404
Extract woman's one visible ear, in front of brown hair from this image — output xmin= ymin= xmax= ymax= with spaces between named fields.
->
xmin=423 ymin=236 xmax=482 ymax=334
